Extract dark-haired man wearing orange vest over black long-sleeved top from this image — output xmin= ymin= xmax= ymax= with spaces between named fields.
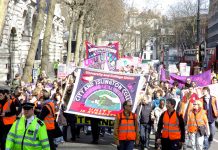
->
xmin=157 ymin=99 xmax=185 ymax=150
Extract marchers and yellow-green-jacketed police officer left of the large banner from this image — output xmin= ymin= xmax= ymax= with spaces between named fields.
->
xmin=0 ymin=71 xmax=94 ymax=150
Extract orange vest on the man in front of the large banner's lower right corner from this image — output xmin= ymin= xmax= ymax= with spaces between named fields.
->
xmin=118 ymin=112 xmax=137 ymax=140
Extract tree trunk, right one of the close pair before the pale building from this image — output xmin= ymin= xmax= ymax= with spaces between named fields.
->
xmin=41 ymin=0 xmax=56 ymax=70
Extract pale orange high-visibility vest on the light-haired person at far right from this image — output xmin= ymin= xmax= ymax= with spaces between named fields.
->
xmin=187 ymin=109 xmax=208 ymax=133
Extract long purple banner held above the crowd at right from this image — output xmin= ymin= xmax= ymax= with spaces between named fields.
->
xmin=161 ymin=69 xmax=211 ymax=86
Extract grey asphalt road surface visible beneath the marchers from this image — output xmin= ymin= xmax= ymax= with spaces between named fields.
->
xmin=57 ymin=126 xmax=218 ymax=150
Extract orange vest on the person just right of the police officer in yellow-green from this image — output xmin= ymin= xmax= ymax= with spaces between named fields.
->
xmin=43 ymin=102 xmax=55 ymax=130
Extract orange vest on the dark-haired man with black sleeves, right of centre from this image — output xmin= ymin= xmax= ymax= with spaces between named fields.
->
xmin=162 ymin=111 xmax=181 ymax=140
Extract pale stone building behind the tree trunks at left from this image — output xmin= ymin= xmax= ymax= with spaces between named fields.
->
xmin=0 ymin=0 xmax=66 ymax=81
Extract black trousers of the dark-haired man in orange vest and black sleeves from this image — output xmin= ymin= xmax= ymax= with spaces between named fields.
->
xmin=161 ymin=138 xmax=181 ymax=150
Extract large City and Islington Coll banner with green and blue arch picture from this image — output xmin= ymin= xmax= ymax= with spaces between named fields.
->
xmin=66 ymin=68 xmax=144 ymax=120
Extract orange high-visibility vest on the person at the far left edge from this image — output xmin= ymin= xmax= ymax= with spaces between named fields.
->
xmin=2 ymin=99 xmax=16 ymax=125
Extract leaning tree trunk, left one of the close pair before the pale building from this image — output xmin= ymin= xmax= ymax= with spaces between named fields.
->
xmin=22 ymin=0 xmax=46 ymax=82
